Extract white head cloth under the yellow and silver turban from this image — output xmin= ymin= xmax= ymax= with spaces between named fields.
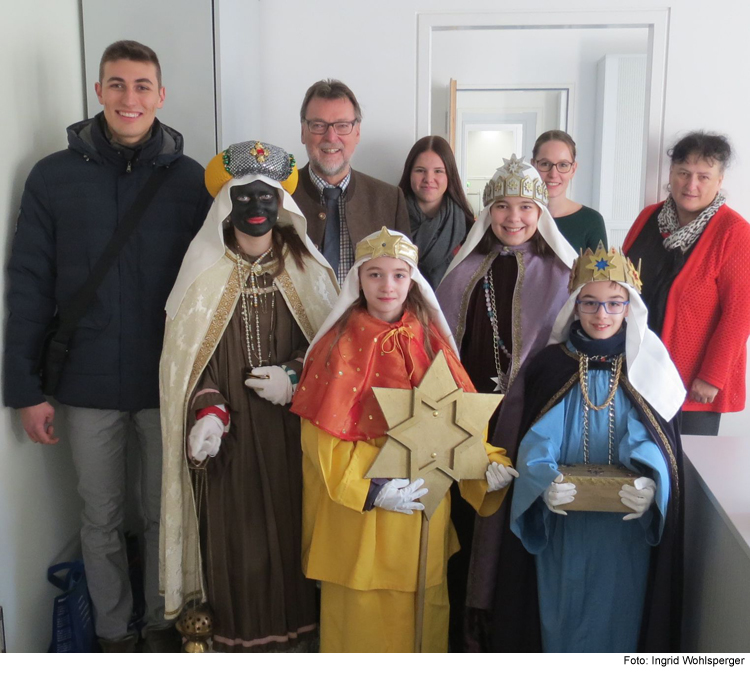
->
xmin=166 ymin=175 xmax=330 ymax=319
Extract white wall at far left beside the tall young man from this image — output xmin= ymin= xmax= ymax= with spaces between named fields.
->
xmin=0 ymin=0 xmax=84 ymax=652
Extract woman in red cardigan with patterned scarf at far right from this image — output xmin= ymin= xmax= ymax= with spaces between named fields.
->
xmin=623 ymin=132 xmax=750 ymax=435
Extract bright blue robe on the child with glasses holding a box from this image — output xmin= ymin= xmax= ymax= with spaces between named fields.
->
xmin=511 ymin=350 xmax=670 ymax=653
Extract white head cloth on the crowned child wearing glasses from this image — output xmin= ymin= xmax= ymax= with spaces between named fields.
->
xmin=549 ymin=281 xmax=685 ymax=421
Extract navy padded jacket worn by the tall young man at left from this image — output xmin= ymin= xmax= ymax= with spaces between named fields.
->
xmin=4 ymin=114 xmax=211 ymax=411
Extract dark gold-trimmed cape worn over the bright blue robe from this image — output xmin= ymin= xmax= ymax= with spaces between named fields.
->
xmin=469 ymin=345 xmax=684 ymax=653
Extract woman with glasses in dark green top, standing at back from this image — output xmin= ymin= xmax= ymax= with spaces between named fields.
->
xmin=531 ymin=130 xmax=607 ymax=253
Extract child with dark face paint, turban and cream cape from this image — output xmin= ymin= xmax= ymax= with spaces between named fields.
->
xmin=161 ymin=140 xmax=344 ymax=652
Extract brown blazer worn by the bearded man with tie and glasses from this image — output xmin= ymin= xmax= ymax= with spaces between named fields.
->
xmin=292 ymin=164 xmax=411 ymax=248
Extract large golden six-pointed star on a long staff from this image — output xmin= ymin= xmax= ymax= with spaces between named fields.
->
xmin=365 ymin=352 xmax=503 ymax=653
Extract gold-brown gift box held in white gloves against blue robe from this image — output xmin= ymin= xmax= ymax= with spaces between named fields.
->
xmin=559 ymin=463 xmax=640 ymax=513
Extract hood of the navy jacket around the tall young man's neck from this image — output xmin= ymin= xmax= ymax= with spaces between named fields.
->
xmin=67 ymin=113 xmax=184 ymax=166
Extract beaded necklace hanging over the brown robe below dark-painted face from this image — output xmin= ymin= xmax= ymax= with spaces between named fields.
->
xmin=237 ymin=246 xmax=276 ymax=377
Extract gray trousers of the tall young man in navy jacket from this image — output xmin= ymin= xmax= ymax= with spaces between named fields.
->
xmin=63 ymin=406 xmax=164 ymax=639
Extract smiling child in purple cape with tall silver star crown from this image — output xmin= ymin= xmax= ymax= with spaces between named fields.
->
xmin=437 ymin=154 xmax=576 ymax=650
